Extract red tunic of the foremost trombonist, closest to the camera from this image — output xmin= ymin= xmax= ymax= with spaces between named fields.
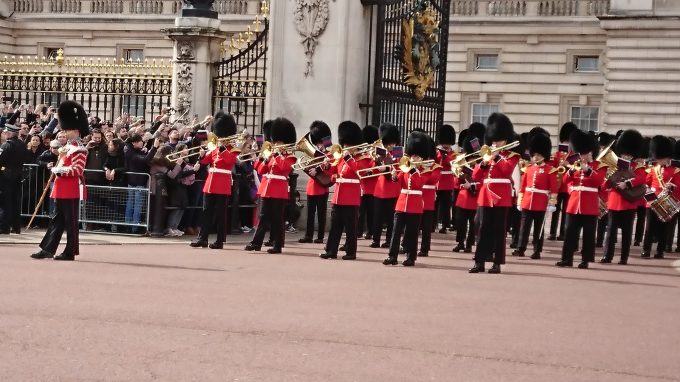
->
xmin=472 ymin=151 xmax=520 ymax=207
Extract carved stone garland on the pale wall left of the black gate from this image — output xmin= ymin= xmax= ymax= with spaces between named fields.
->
xmin=294 ymin=0 xmax=335 ymax=77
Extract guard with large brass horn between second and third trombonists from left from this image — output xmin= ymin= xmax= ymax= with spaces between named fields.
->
xmin=299 ymin=121 xmax=331 ymax=244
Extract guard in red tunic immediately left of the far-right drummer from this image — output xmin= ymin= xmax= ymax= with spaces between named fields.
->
xmin=600 ymin=130 xmax=647 ymax=265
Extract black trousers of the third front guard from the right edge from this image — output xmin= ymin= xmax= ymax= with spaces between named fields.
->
xmin=562 ymin=214 xmax=597 ymax=263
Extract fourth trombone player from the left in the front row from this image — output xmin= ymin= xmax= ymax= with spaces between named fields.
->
xmin=383 ymin=131 xmax=430 ymax=267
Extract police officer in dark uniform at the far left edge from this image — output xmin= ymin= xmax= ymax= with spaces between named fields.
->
xmin=0 ymin=113 xmax=28 ymax=235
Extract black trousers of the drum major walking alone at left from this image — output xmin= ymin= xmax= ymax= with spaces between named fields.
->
xmin=40 ymin=199 xmax=80 ymax=256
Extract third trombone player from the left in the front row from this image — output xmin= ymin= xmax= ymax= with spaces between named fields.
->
xmin=319 ymin=121 xmax=371 ymax=260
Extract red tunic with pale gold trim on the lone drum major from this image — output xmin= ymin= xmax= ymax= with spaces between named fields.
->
xmin=50 ymin=142 xmax=87 ymax=199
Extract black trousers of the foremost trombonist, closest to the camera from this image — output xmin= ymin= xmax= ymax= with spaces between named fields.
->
xmin=475 ymin=207 xmax=510 ymax=264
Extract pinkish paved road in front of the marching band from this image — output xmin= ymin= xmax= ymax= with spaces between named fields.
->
xmin=0 ymin=232 xmax=680 ymax=382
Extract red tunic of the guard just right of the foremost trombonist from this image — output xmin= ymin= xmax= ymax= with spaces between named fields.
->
xmin=519 ymin=164 xmax=557 ymax=211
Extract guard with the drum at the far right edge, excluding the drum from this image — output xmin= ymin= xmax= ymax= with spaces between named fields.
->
xmin=642 ymin=135 xmax=680 ymax=259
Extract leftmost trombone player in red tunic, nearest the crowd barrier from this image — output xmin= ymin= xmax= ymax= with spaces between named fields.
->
xmin=189 ymin=111 xmax=240 ymax=249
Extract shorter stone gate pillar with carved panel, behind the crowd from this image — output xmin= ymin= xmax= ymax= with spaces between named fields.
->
xmin=162 ymin=17 xmax=226 ymax=120
